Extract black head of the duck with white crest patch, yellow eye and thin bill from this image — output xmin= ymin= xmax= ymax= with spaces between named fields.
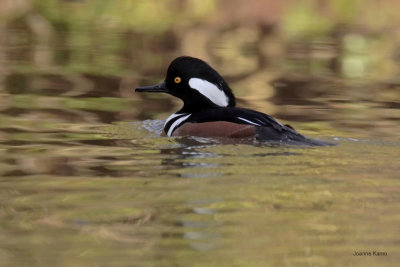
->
xmin=136 ymin=57 xmax=235 ymax=112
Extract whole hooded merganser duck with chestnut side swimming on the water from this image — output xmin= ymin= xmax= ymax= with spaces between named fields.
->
xmin=135 ymin=56 xmax=332 ymax=146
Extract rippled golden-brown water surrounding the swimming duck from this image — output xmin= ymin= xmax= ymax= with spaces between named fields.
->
xmin=0 ymin=2 xmax=400 ymax=266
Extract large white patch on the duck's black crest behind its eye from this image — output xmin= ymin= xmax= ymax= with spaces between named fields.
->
xmin=189 ymin=78 xmax=229 ymax=107
